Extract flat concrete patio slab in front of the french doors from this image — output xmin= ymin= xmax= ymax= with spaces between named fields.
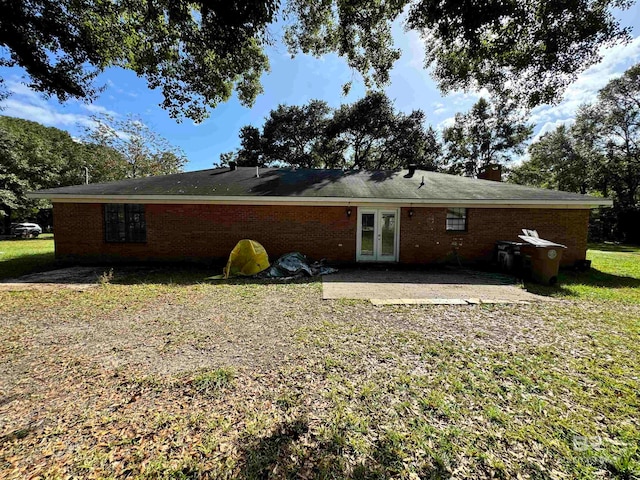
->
xmin=322 ymin=269 xmax=551 ymax=305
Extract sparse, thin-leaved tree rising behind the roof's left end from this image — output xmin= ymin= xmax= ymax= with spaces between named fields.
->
xmin=85 ymin=115 xmax=187 ymax=178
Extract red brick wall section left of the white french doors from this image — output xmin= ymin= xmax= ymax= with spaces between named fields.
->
xmin=53 ymin=203 xmax=357 ymax=262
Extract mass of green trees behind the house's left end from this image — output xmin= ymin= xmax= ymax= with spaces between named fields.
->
xmin=0 ymin=117 xmax=186 ymax=229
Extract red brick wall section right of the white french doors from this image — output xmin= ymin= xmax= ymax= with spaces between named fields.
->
xmin=400 ymin=208 xmax=589 ymax=265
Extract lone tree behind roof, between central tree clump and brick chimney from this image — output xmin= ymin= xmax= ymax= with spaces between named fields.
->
xmin=443 ymin=98 xmax=533 ymax=176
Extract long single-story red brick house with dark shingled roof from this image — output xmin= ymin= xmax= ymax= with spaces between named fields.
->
xmin=30 ymin=165 xmax=611 ymax=265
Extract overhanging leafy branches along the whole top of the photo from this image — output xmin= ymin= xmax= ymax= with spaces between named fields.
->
xmin=0 ymin=0 xmax=631 ymax=121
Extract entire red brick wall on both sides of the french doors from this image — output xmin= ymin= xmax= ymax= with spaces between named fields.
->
xmin=54 ymin=203 xmax=589 ymax=264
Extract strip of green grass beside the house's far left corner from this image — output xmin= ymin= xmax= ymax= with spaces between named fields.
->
xmin=0 ymin=233 xmax=54 ymax=280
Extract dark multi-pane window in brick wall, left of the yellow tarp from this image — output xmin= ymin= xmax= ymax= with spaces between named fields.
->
xmin=104 ymin=203 xmax=147 ymax=243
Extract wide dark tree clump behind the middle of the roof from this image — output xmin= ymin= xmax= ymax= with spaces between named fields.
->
xmin=221 ymin=93 xmax=441 ymax=170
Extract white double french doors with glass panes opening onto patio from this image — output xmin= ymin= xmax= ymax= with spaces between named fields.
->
xmin=356 ymin=208 xmax=400 ymax=262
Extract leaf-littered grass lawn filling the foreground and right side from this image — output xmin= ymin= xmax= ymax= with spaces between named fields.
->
xmin=0 ymin=240 xmax=640 ymax=479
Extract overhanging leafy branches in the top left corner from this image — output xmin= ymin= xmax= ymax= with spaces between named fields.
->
xmin=0 ymin=0 xmax=277 ymax=121
